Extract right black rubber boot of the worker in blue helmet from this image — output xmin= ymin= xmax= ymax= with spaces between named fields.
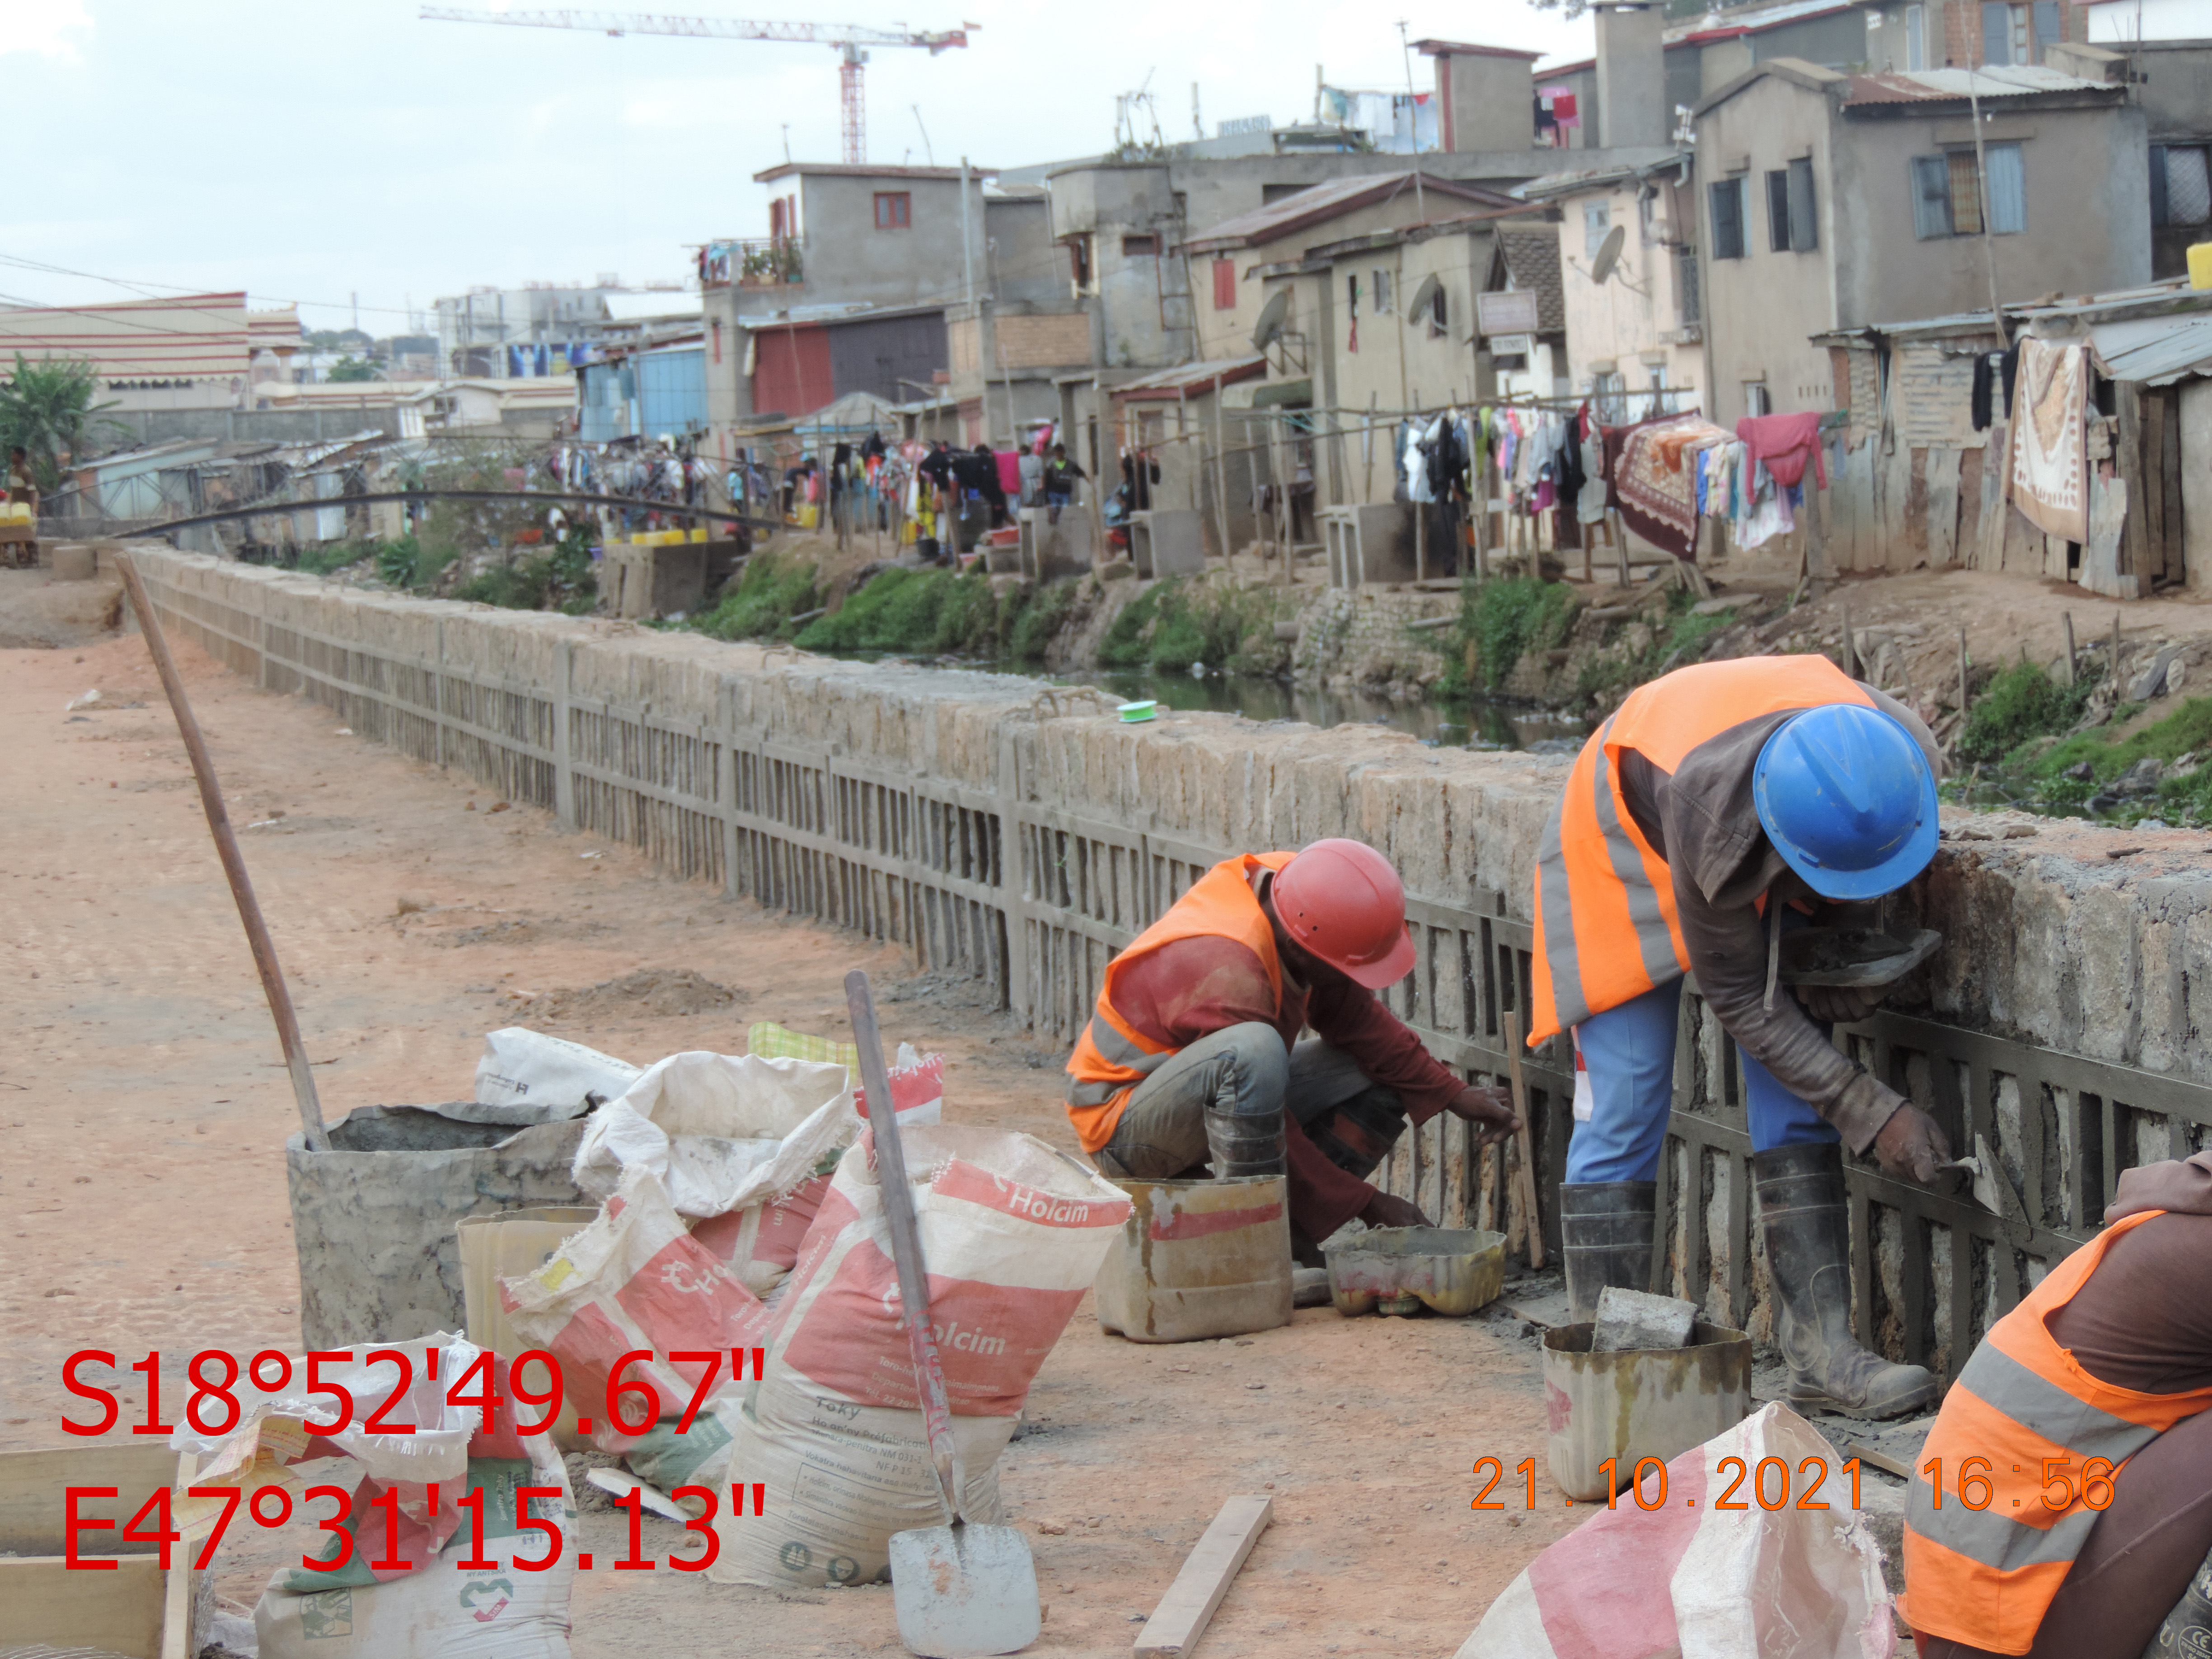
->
xmin=1752 ymin=1141 xmax=1936 ymax=1418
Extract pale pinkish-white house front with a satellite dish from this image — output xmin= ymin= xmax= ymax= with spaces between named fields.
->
xmin=1515 ymin=150 xmax=1706 ymax=425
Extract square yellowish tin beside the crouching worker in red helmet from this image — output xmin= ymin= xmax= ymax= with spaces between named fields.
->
xmin=1093 ymin=1175 xmax=1292 ymax=1343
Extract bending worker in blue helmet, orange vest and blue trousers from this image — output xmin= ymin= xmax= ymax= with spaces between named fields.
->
xmin=1528 ymin=657 xmax=1951 ymax=1418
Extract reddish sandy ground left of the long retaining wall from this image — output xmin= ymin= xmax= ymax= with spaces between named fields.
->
xmin=0 ymin=619 xmax=1579 ymax=1659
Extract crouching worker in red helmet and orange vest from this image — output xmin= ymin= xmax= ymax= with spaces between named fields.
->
xmin=1066 ymin=840 xmax=1520 ymax=1254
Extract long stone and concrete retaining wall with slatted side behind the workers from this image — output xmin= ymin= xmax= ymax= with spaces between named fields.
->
xmin=139 ymin=548 xmax=2212 ymax=1369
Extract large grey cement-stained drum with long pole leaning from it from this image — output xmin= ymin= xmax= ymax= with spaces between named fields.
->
xmin=286 ymin=1101 xmax=590 ymax=1350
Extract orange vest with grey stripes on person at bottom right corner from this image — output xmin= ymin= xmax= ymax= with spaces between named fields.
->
xmin=1904 ymin=1210 xmax=2212 ymax=1652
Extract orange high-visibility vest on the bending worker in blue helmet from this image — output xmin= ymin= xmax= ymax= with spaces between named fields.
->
xmin=1528 ymin=657 xmax=1874 ymax=1049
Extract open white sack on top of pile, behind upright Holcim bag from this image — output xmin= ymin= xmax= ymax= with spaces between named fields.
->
xmin=573 ymin=1051 xmax=861 ymax=1219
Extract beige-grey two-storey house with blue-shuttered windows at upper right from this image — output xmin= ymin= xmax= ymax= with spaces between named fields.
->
xmin=1696 ymin=57 xmax=2150 ymax=425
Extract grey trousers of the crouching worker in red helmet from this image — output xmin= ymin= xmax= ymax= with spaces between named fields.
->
xmin=1095 ymin=1020 xmax=1405 ymax=1181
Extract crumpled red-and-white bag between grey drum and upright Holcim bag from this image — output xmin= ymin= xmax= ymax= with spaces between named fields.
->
xmin=500 ymin=1166 xmax=770 ymax=1453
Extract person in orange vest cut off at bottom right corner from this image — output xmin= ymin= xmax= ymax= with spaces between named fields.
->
xmin=1903 ymin=1153 xmax=2212 ymax=1659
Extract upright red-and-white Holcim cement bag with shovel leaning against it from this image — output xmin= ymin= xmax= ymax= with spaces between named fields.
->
xmin=708 ymin=1126 xmax=1128 ymax=1586
